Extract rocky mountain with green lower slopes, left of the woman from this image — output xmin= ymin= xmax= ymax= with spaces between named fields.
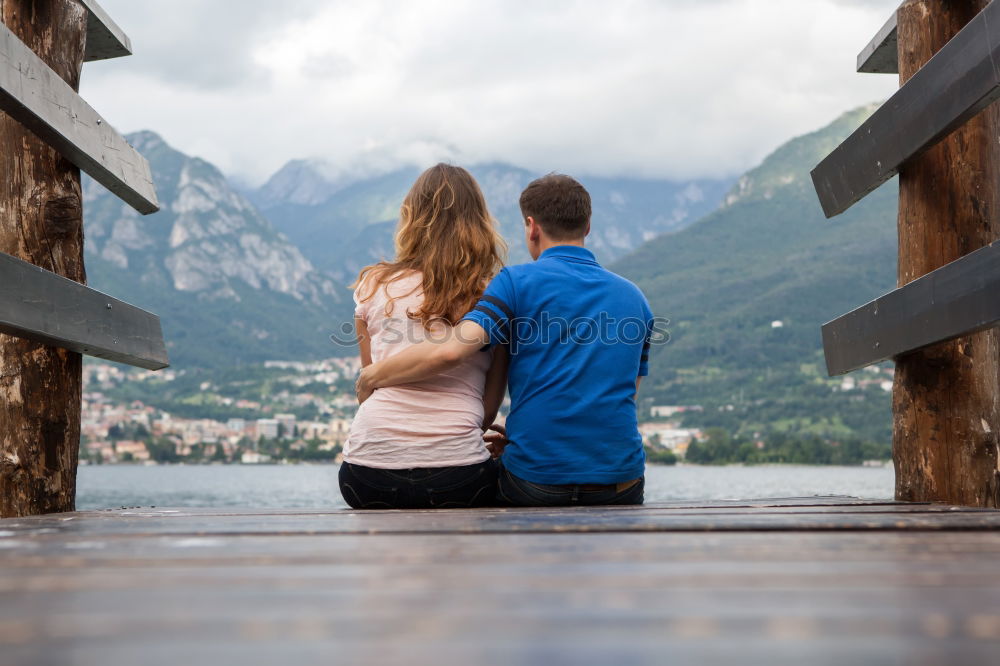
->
xmin=84 ymin=132 xmax=351 ymax=368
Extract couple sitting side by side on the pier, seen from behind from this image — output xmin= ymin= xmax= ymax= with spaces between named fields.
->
xmin=340 ymin=164 xmax=653 ymax=509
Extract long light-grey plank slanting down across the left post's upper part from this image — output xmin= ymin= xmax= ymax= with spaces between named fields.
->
xmin=0 ymin=24 xmax=160 ymax=214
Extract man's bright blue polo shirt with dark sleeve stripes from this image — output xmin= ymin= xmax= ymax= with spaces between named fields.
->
xmin=464 ymin=245 xmax=653 ymax=485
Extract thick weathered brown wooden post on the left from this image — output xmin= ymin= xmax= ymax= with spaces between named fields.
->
xmin=0 ymin=0 xmax=88 ymax=517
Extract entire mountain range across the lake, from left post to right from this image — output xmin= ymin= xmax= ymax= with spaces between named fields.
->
xmin=84 ymin=106 xmax=897 ymax=441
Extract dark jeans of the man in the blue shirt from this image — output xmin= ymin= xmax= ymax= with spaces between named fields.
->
xmin=497 ymin=464 xmax=646 ymax=506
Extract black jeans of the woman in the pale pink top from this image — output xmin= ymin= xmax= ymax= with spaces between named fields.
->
xmin=340 ymin=460 xmax=497 ymax=509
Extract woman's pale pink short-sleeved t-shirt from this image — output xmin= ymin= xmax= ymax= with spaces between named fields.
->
xmin=344 ymin=272 xmax=492 ymax=469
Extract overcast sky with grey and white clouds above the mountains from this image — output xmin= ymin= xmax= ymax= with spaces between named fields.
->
xmin=82 ymin=0 xmax=899 ymax=183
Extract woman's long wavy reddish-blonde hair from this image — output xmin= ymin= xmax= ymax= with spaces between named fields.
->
xmin=351 ymin=164 xmax=507 ymax=329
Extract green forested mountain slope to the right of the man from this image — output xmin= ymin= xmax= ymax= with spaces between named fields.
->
xmin=611 ymin=106 xmax=898 ymax=441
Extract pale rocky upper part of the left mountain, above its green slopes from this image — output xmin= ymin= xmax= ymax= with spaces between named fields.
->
xmin=86 ymin=131 xmax=338 ymax=305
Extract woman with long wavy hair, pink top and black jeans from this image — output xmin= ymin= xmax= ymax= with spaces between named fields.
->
xmin=340 ymin=164 xmax=508 ymax=509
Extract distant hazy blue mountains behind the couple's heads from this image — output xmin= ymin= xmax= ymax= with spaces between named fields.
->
xmin=247 ymin=160 xmax=732 ymax=281
